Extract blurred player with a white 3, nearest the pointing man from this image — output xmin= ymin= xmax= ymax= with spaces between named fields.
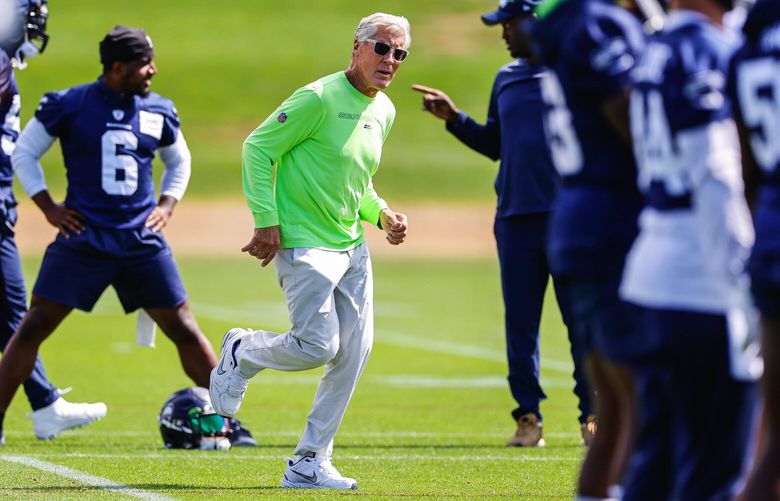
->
xmin=528 ymin=0 xmax=645 ymax=498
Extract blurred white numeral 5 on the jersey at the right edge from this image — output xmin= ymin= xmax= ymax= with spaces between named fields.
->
xmin=737 ymin=58 xmax=780 ymax=172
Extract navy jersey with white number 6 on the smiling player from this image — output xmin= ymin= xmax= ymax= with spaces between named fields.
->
xmin=35 ymin=79 xmax=179 ymax=229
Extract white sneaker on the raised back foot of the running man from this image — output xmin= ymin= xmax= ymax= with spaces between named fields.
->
xmin=209 ymin=327 xmax=249 ymax=417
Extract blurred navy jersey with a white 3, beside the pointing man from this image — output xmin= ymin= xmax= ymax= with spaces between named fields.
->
xmin=532 ymin=0 xmax=645 ymax=278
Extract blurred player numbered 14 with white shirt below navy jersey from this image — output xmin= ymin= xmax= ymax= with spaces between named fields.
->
xmin=621 ymin=0 xmax=760 ymax=494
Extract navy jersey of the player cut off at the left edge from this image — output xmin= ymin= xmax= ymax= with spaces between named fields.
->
xmin=0 ymin=49 xmax=22 ymax=183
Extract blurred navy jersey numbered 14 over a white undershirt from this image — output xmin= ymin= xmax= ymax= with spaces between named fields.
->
xmin=631 ymin=11 xmax=739 ymax=211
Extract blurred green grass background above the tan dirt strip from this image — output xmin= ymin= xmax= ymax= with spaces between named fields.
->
xmin=17 ymin=0 xmax=510 ymax=203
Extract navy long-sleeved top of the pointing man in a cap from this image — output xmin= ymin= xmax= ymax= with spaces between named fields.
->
xmin=447 ymin=59 xmax=560 ymax=217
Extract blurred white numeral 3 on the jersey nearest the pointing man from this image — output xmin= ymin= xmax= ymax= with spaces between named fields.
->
xmin=541 ymin=71 xmax=583 ymax=176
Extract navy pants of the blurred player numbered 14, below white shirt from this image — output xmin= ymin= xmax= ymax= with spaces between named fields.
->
xmin=623 ymin=308 xmax=757 ymax=500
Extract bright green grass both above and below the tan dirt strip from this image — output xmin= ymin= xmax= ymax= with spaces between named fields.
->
xmin=0 ymin=0 xmax=584 ymax=494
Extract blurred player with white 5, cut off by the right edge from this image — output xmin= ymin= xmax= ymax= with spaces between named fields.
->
xmin=728 ymin=0 xmax=780 ymax=501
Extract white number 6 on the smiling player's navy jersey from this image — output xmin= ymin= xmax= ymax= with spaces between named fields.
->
xmin=101 ymin=129 xmax=138 ymax=195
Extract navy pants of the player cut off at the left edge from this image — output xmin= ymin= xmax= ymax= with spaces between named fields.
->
xmin=0 ymin=192 xmax=59 ymax=411
